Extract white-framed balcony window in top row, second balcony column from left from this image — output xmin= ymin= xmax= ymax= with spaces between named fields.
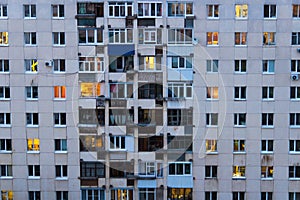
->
xmin=108 ymin=2 xmax=133 ymax=17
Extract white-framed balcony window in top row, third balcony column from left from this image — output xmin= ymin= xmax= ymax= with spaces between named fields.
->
xmin=138 ymin=3 xmax=162 ymax=17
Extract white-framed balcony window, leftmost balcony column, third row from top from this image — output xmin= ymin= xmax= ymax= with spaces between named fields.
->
xmin=79 ymin=57 xmax=104 ymax=73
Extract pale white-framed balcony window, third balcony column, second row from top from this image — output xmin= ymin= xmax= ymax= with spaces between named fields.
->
xmin=138 ymin=28 xmax=162 ymax=44
